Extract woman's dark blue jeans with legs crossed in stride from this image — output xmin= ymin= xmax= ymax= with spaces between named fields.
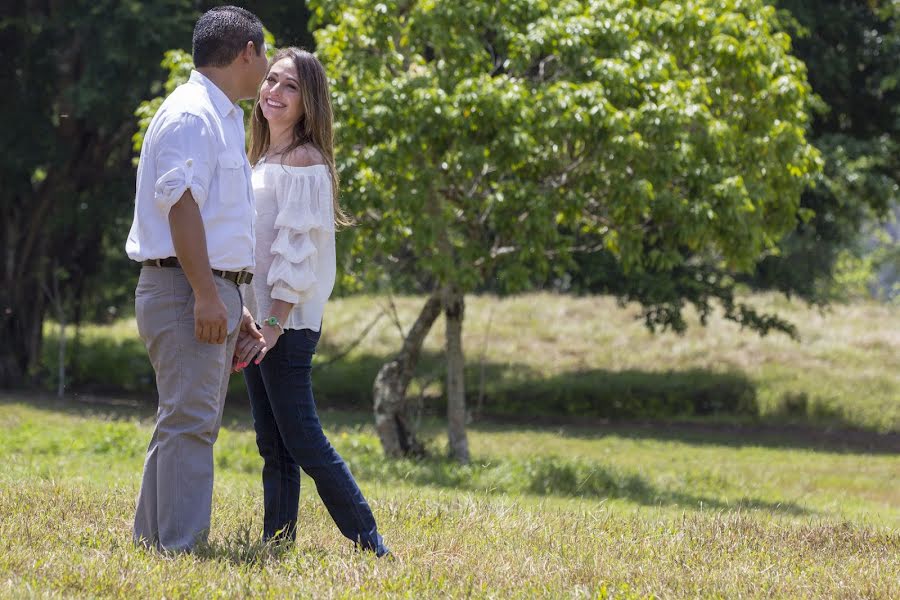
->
xmin=244 ymin=329 xmax=388 ymax=556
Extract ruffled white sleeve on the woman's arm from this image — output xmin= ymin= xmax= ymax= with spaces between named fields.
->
xmin=266 ymin=169 xmax=334 ymax=304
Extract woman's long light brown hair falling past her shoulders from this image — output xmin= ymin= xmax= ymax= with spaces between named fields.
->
xmin=248 ymin=47 xmax=353 ymax=227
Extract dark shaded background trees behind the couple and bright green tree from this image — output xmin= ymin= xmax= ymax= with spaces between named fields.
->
xmin=0 ymin=0 xmax=900 ymax=387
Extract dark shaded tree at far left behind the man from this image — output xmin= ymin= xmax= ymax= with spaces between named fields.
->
xmin=0 ymin=0 xmax=196 ymax=387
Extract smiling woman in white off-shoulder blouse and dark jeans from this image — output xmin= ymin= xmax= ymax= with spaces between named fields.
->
xmin=235 ymin=48 xmax=389 ymax=556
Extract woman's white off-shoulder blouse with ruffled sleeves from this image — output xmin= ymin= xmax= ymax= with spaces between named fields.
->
xmin=248 ymin=162 xmax=336 ymax=331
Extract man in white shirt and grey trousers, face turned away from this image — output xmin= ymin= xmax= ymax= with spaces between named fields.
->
xmin=126 ymin=6 xmax=266 ymax=551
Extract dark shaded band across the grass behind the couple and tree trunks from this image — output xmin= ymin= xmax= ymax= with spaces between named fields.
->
xmin=37 ymin=328 xmax=900 ymax=440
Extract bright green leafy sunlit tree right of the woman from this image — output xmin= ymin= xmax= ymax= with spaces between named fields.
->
xmin=310 ymin=0 xmax=819 ymax=461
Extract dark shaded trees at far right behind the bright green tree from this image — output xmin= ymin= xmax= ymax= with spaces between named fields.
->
xmin=568 ymin=0 xmax=900 ymax=334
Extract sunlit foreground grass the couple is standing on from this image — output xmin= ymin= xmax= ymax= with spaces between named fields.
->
xmin=0 ymin=396 xmax=900 ymax=598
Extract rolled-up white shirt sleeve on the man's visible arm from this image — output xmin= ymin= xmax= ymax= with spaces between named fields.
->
xmin=154 ymin=114 xmax=216 ymax=217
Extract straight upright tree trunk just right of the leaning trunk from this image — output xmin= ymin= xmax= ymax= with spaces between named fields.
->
xmin=443 ymin=285 xmax=469 ymax=464
